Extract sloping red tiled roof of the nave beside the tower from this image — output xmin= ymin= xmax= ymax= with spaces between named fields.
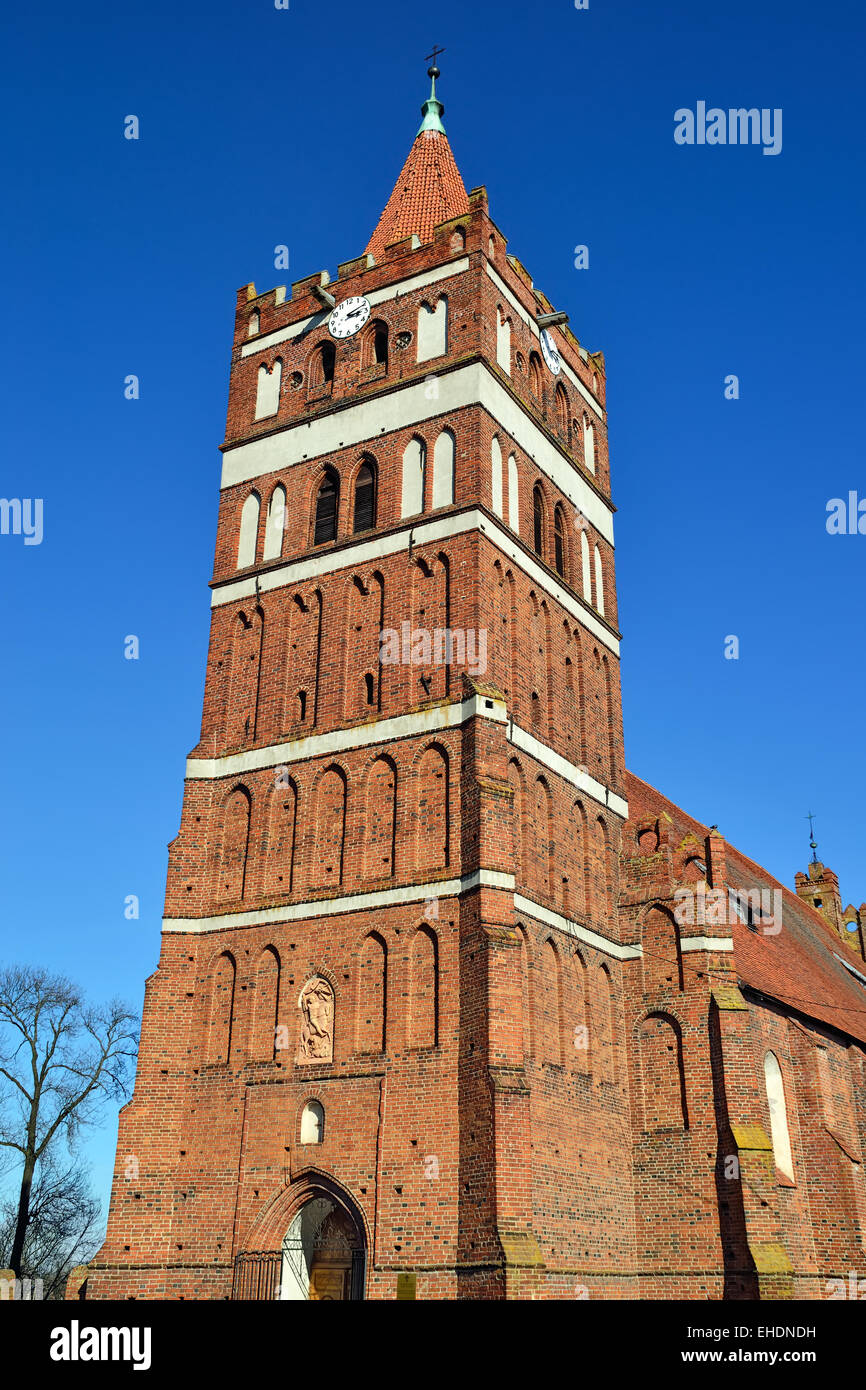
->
xmin=626 ymin=773 xmax=866 ymax=1043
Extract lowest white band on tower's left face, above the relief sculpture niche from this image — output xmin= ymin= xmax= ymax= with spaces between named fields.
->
xmin=163 ymin=869 xmax=514 ymax=931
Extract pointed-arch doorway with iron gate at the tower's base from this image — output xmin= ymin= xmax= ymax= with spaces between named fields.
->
xmin=279 ymin=1193 xmax=364 ymax=1302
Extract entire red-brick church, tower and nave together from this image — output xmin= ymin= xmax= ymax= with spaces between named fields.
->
xmin=79 ymin=67 xmax=866 ymax=1298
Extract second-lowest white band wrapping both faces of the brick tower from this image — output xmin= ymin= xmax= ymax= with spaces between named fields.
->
xmin=186 ymin=695 xmax=628 ymax=819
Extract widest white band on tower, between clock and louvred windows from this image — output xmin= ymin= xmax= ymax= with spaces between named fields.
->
xmin=221 ymin=361 xmax=613 ymax=545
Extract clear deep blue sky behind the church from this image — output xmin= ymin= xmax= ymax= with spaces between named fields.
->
xmin=0 ymin=0 xmax=866 ymax=1217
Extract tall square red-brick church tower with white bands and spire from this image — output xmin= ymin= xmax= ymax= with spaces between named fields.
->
xmin=88 ymin=65 xmax=625 ymax=1300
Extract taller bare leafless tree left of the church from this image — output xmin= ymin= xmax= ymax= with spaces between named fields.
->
xmin=0 ymin=966 xmax=138 ymax=1277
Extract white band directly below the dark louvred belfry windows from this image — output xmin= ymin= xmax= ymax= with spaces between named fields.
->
xmin=210 ymin=510 xmax=620 ymax=656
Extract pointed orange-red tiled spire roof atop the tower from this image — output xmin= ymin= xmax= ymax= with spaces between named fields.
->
xmin=367 ymin=131 xmax=468 ymax=257
